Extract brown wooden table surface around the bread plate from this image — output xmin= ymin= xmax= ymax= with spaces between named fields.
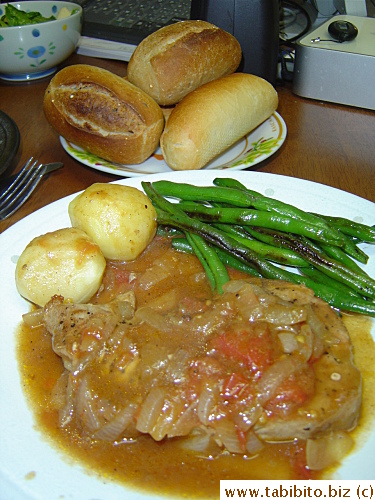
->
xmin=0 ymin=54 xmax=375 ymax=233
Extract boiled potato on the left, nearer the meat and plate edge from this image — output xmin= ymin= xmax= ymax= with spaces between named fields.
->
xmin=15 ymin=228 xmax=106 ymax=307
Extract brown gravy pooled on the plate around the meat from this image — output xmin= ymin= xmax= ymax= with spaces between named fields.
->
xmin=17 ymin=237 xmax=375 ymax=498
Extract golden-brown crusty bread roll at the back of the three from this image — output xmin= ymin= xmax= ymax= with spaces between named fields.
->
xmin=127 ymin=21 xmax=242 ymax=106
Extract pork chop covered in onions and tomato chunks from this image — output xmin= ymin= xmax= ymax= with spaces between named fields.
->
xmin=44 ymin=278 xmax=361 ymax=453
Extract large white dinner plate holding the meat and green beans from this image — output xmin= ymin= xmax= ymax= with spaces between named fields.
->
xmin=0 ymin=171 xmax=375 ymax=500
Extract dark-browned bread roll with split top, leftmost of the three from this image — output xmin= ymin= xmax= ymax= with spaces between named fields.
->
xmin=43 ymin=64 xmax=164 ymax=164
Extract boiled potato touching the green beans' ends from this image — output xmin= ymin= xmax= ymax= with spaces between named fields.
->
xmin=68 ymin=183 xmax=156 ymax=261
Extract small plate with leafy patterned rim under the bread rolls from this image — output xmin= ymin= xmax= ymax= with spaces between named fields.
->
xmin=60 ymin=112 xmax=287 ymax=177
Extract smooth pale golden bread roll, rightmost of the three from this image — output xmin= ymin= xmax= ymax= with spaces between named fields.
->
xmin=160 ymin=73 xmax=278 ymax=170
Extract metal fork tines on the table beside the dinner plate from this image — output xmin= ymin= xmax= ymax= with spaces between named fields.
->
xmin=0 ymin=157 xmax=46 ymax=220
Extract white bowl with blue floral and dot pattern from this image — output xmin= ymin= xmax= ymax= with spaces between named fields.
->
xmin=0 ymin=1 xmax=82 ymax=81
